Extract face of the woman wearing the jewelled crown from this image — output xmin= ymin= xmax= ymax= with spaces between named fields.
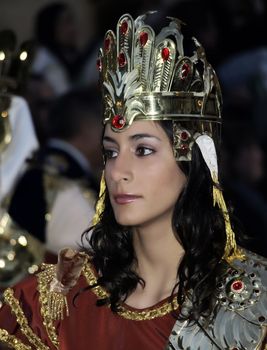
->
xmin=103 ymin=121 xmax=186 ymax=227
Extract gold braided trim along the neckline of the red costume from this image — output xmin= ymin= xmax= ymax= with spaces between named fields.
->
xmin=83 ymin=264 xmax=179 ymax=321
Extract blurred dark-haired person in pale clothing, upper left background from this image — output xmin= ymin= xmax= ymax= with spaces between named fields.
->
xmin=31 ymin=2 xmax=92 ymax=95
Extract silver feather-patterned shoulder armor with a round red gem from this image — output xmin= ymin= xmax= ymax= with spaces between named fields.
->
xmin=167 ymin=251 xmax=267 ymax=350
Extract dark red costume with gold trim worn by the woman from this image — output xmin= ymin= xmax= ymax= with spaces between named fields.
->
xmin=0 ymin=256 xmax=180 ymax=350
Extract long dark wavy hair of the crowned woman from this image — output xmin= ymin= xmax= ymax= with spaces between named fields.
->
xmin=83 ymin=121 xmax=237 ymax=320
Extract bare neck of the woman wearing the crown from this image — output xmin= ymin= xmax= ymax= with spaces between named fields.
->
xmin=127 ymin=222 xmax=184 ymax=308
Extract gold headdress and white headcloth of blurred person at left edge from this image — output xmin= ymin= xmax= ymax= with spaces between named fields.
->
xmin=0 ymin=30 xmax=39 ymax=206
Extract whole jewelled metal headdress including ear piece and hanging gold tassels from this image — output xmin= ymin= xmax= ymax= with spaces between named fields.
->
xmin=94 ymin=12 xmax=244 ymax=259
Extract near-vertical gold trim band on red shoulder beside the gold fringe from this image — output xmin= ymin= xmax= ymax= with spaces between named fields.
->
xmin=38 ymin=264 xmax=59 ymax=348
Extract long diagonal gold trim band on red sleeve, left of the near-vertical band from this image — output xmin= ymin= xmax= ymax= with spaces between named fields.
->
xmin=4 ymin=288 xmax=49 ymax=350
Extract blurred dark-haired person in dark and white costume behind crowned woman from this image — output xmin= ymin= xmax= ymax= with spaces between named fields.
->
xmin=9 ymin=89 xmax=101 ymax=260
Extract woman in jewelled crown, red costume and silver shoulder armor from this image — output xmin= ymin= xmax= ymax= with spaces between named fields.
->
xmin=0 ymin=14 xmax=267 ymax=350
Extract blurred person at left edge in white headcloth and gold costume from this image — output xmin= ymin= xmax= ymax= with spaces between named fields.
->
xmin=0 ymin=30 xmax=44 ymax=290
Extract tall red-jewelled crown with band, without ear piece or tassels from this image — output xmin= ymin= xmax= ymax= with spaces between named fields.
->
xmin=98 ymin=12 xmax=221 ymax=131
